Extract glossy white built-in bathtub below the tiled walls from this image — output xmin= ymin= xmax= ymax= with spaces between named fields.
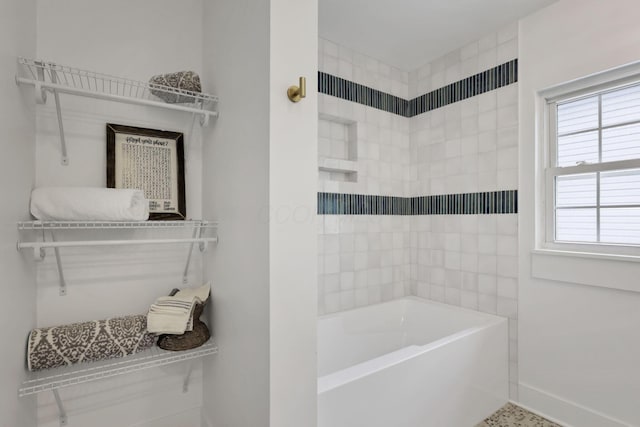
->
xmin=318 ymin=297 xmax=508 ymax=427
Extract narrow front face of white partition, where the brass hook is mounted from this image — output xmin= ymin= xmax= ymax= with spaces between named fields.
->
xmin=269 ymin=0 xmax=318 ymax=427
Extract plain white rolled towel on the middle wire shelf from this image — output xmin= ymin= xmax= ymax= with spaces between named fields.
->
xmin=31 ymin=187 xmax=149 ymax=221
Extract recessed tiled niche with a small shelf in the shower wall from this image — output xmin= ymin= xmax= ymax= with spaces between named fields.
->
xmin=318 ymin=114 xmax=358 ymax=182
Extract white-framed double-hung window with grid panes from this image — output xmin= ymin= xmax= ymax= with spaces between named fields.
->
xmin=545 ymin=80 xmax=640 ymax=254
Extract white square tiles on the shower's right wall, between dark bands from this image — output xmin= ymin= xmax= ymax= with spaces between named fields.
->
xmin=409 ymin=24 xmax=518 ymax=399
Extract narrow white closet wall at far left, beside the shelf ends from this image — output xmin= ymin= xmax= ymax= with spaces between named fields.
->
xmin=0 ymin=0 xmax=36 ymax=427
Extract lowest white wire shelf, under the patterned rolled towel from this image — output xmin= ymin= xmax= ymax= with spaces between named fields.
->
xmin=18 ymin=342 xmax=218 ymax=397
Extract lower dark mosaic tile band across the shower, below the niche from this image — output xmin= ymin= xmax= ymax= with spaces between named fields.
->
xmin=318 ymin=190 xmax=518 ymax=215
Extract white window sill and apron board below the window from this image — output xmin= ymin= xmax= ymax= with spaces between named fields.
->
xmin=531 ymin=249 xmax=640 ymax=292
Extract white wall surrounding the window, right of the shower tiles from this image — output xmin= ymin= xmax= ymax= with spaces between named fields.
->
xmin=519 ymin=0 xmax=640 ymax=427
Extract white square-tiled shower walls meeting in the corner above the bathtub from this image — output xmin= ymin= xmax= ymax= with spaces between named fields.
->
xmin=318 ymin=23 xmax=518 ymax=399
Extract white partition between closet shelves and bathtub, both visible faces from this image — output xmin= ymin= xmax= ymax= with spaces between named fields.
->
xmin=203 ymin=0 xmax=317 ymax=427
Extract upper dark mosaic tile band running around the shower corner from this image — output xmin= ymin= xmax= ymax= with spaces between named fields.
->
xmin=318 ymin=58 xmax=518 ymax=117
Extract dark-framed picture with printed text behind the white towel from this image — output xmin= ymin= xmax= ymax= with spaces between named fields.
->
xmin=107 ymin=123 xmax=187 ymax=220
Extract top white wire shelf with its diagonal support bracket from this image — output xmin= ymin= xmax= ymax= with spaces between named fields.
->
xmin=16 ymin=57 xmax=218 ymax=165
